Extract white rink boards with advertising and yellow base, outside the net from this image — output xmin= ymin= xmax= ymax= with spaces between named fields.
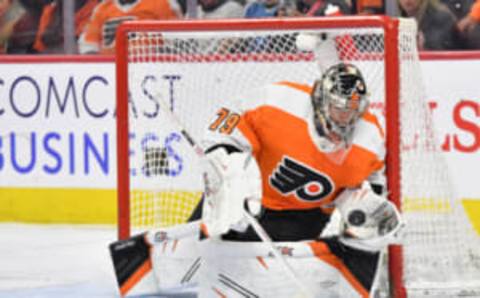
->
xmin=0 ymin=56 xmax=480 ymax=233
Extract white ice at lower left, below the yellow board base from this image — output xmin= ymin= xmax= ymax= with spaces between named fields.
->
xmin=0 ymin=223 xmax=119 ymax=298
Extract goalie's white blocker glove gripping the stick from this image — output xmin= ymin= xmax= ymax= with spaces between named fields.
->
xmin=202 ymin=148 xmax=262 ymax=236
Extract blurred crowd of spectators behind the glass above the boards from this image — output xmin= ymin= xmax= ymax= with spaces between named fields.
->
xmin=0 ymin=0 xmax=480 ymax=54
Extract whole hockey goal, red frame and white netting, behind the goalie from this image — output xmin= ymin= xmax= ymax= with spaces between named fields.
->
xmin=117 ymin=17 xmax=480 ymax=297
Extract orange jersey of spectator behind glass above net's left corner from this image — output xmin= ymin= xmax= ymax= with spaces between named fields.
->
xmin=79 ymin=0 xmax=181 ymax=54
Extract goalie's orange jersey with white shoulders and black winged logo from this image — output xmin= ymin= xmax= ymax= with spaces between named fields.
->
xmin=207 ymin=82 xmax=385 ymax=213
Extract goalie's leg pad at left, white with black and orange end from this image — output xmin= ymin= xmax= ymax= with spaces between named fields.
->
xmin=110 ymin=222 xmax=201 ymax=297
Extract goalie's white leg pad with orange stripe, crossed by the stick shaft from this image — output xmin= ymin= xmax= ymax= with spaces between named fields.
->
xmin=199 ymin=241 xmax=376 ymax=298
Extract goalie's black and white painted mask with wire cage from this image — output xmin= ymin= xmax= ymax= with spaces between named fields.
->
xmin=312 ymin=63 xmax=368 ymax=145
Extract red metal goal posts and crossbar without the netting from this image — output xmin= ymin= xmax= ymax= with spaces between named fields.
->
xmin=115 ymin=16 xmax=407 ymax=297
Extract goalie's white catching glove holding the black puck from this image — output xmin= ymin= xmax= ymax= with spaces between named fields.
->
xmin=335 ymin=183 xmax=404 ymax=251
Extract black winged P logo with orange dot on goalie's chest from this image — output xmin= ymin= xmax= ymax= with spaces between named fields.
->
xmin=270 ymin=157 xmax=334 ymax=202
